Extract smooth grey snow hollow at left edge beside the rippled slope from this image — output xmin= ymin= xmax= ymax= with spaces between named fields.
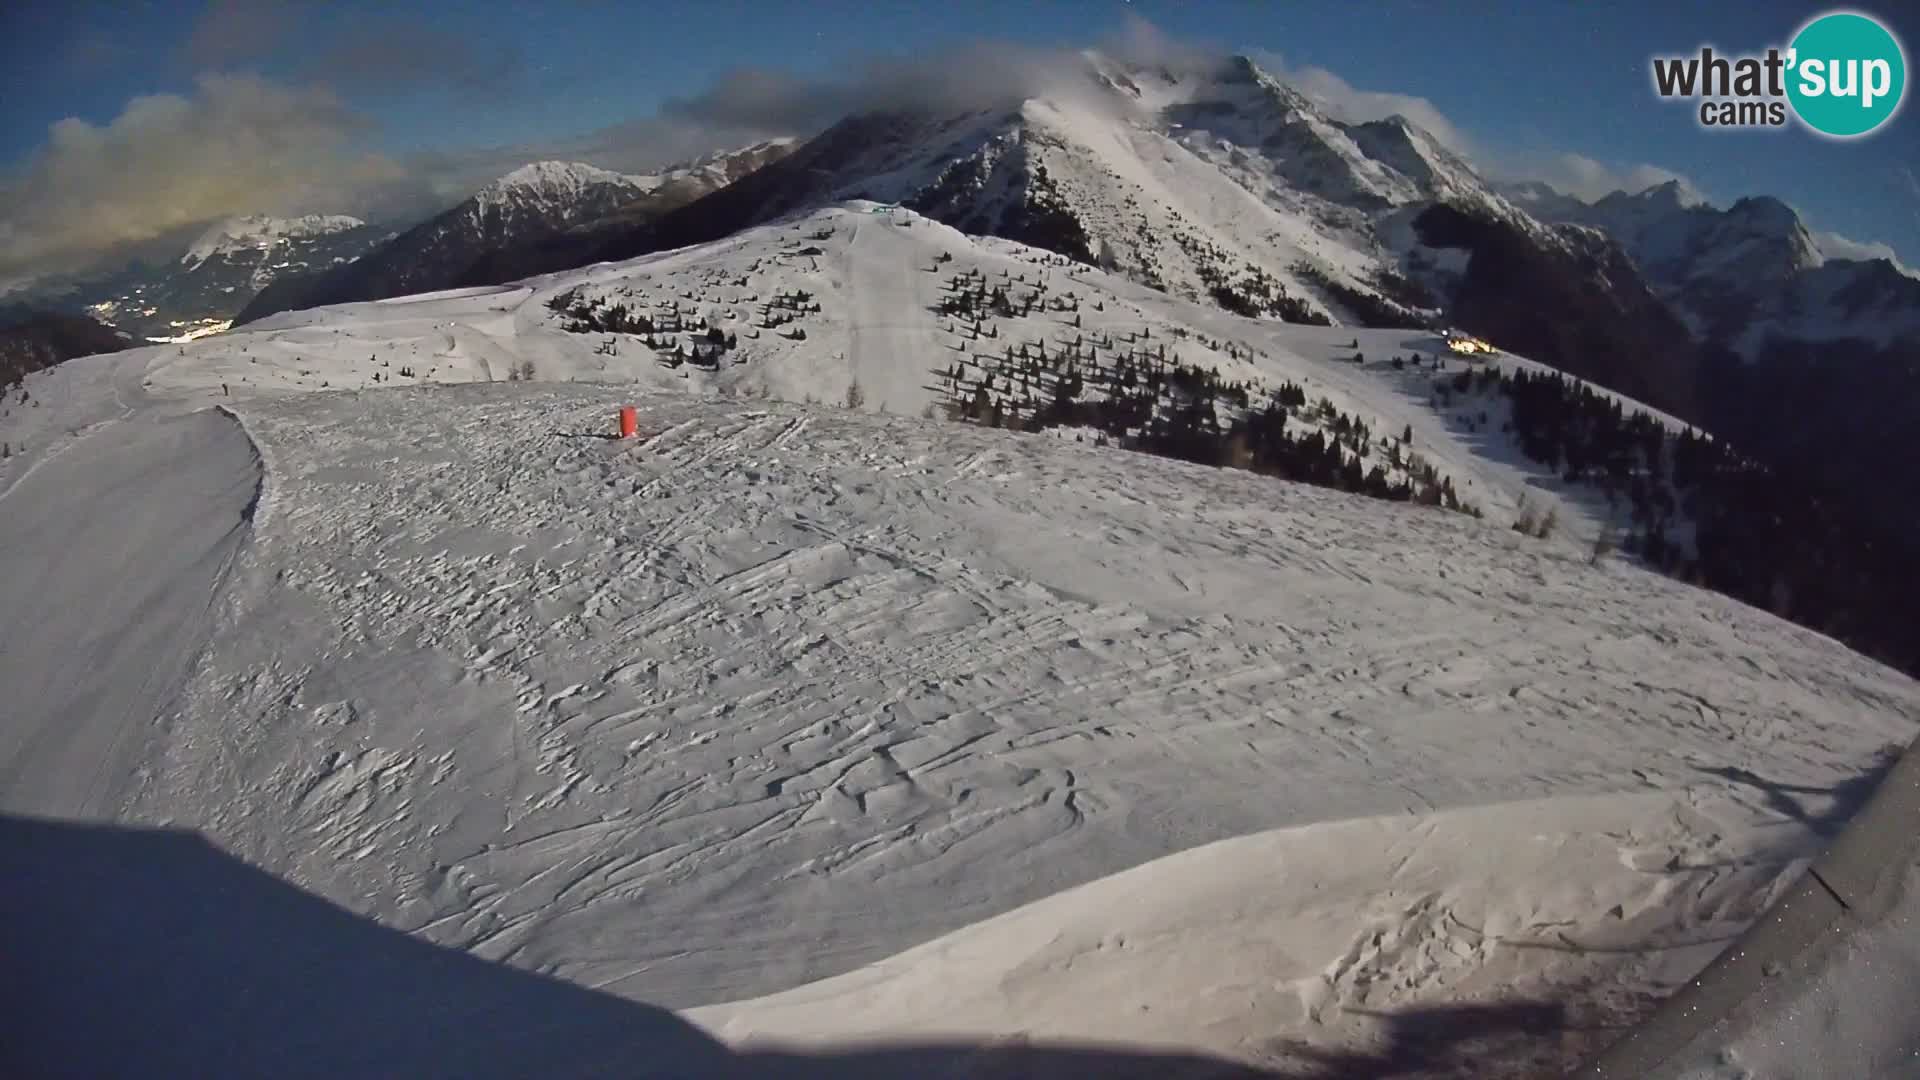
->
xmin=0 ymin=403 xmax=263 ymax=817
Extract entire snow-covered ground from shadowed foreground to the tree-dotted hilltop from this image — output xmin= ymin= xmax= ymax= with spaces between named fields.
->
xmin=0 ymin=205 xmax=1920 ymax=1078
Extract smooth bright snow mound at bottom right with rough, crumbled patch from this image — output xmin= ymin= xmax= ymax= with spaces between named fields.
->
xmin=685 ymin=794 xmax=1816 ymax=1080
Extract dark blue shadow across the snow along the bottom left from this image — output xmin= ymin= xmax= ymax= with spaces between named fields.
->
xmin=0 ymin=815 xmax=1563 ymax=1080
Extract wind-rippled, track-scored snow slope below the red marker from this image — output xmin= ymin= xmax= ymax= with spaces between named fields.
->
xmin=138 ymin=384 xmax=1920 ymax=1063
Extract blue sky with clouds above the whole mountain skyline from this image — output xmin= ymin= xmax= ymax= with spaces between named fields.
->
xmin=0 ymin=0 xmax=1920 ymax=265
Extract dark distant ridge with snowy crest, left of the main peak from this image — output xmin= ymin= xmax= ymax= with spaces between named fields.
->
xmin=236 ymin=140 xmax=789 ymax=323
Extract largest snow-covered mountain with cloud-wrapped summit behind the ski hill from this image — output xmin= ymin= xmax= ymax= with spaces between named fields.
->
xmin=691 ymin=52 xmax=1565 ymax=323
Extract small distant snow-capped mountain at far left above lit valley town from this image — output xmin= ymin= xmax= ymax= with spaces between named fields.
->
xmin=25 ymin=215 xmax=390 ymax=340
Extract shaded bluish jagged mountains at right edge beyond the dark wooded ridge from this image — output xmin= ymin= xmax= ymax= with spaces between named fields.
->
xmin=1507 ymin=183 xmax=1920 ymax=545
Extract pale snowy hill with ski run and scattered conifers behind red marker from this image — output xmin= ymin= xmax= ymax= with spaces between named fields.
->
xmin=168 ymin=204 xmax=1680 ymax=542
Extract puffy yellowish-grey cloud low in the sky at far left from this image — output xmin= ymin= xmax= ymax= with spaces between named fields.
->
xmin=0 ymin=75 xmax=399 ymax=277
